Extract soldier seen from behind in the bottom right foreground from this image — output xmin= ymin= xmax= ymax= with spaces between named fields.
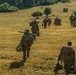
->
xmin=58 ymin=42 xmax=75 ymax=75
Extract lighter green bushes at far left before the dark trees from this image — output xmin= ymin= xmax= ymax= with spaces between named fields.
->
xmin=0 ymin=2 xmax=18 ymax=12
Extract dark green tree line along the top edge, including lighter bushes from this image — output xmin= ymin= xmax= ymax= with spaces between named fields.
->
xmin=0 ymin=0 xmax=69 ymax=11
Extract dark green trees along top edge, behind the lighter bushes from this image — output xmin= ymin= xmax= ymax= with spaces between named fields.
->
xmin=0 ymin=0 xmax=69 ymax=9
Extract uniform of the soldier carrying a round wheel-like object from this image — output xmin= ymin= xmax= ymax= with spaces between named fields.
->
xmin=20 ymin=32 xmax=34 ymax=60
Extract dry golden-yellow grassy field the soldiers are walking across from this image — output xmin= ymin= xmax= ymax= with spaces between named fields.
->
xmin=0 ymin=1 xmax=76 ymax=75
